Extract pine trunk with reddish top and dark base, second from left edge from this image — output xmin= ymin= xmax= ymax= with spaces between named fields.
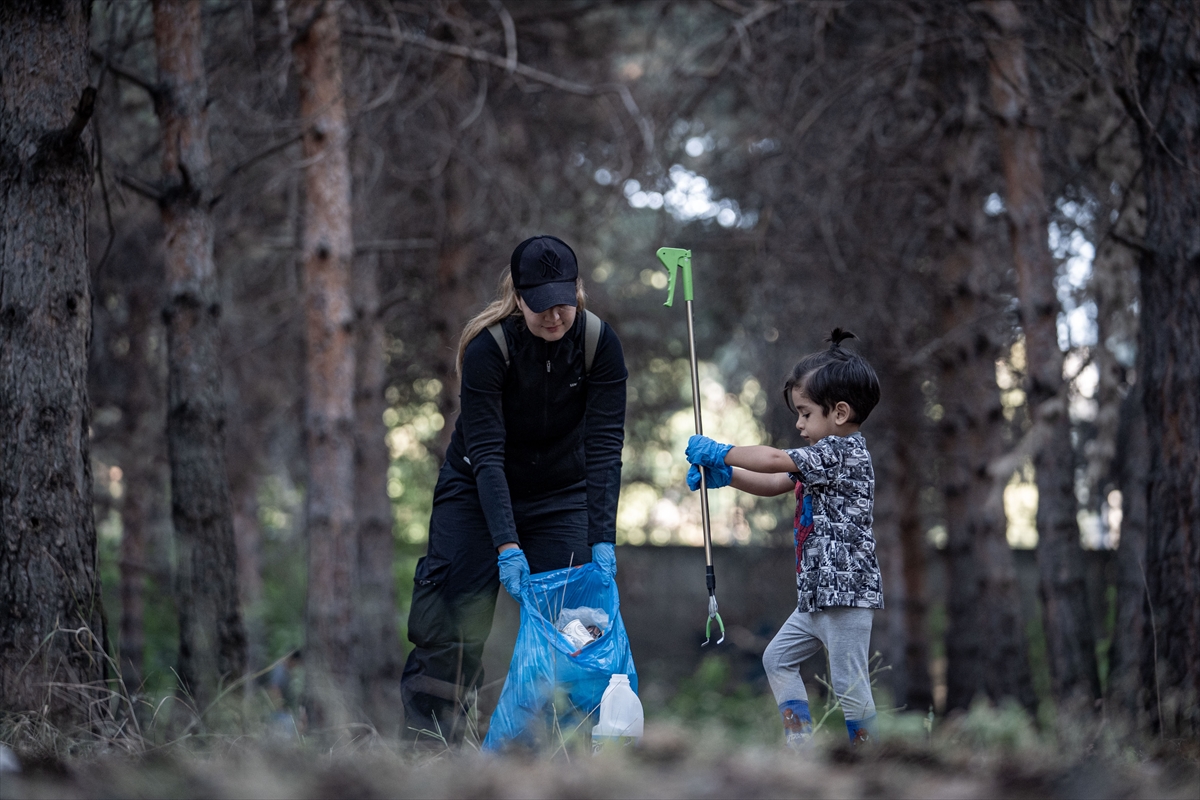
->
xmin=154 ymin=0 xmax=246 ymax=714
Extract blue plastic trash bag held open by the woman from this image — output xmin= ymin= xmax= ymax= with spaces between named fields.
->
xmin=484 ymin=564 xmax=637 ymax=751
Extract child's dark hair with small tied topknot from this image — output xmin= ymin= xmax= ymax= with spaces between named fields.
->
xmin=784 ymin=327 xmax=880 ymax=425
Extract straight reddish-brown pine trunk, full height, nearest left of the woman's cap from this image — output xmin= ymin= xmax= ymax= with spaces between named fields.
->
xmin=293 ymin=2 xmax=359 ymax=727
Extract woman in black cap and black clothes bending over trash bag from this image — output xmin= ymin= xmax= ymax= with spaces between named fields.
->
xmin=402 ymin=236 xmax=628 ymax=742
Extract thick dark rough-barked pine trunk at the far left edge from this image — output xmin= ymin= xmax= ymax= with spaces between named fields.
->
xmin=0 ymin=0 xmax=107 ymax=724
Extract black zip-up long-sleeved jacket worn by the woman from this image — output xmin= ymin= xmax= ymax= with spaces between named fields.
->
xmin=446 ymin=313 xmax=629 ymax=547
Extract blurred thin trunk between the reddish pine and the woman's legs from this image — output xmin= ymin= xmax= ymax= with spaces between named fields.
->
xmin=354 ymin=253 xmax=404 ymax=735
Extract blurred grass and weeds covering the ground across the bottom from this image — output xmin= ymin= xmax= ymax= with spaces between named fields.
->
xmin=0 ymin=657 xmax=1200 ymax=800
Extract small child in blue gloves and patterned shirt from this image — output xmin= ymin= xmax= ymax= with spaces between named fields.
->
xmin=688 ymin=329 xmax=883 ymax=747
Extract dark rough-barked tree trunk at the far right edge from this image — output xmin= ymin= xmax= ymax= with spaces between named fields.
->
xmin=1136 ymin=0 xmax=1200 ymax=735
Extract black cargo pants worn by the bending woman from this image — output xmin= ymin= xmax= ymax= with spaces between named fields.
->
xmin=401 ymin=464 xmax=592 ymax=744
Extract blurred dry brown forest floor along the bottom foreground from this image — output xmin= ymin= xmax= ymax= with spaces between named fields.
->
xmin=0 ymin=710 xmax=1200 ymax=800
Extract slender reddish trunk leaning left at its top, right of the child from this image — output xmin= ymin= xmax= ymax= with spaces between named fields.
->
xmin=983 ymin=0 xmax=1100 ymax=702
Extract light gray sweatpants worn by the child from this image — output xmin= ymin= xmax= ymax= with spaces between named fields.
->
xmin=762 ymin=607 xmax=875 ymax=720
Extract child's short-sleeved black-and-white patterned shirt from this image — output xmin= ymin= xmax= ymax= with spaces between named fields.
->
xmin=785 ymin=433 xmax=883 ymax=612
